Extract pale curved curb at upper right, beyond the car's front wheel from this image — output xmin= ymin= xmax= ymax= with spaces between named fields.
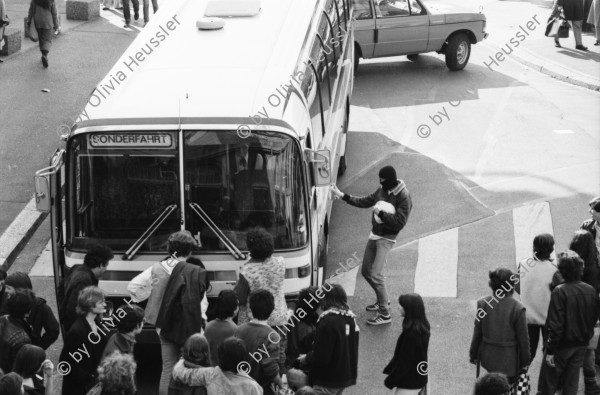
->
xmin=486 ymin=40 xmax=600 ymax=91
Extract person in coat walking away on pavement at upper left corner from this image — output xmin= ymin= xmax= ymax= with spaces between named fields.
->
xmin=27 ymin=0 xmax=59 ymax=68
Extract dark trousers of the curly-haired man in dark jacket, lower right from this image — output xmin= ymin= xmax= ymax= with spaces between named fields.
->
xmin=538 ymin=346 xmax=587 ymax=395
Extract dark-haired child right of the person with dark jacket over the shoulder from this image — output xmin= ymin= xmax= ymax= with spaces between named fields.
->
xmin=204 ymin=289 xmax=239 ymax=366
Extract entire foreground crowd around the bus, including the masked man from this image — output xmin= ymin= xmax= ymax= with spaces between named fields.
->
xmin=0 ymin=162 xmax=600 ymax=395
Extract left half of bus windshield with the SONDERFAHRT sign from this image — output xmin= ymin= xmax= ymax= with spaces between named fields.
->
xmin=68 ymin=132 xmax=180 ymax=252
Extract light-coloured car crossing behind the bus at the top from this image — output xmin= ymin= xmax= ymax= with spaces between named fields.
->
xmin=354 ymin=0 xmax=488 ymax=70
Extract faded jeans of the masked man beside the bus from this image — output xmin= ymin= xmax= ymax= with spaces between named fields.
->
xmin=361 ymin=239 xmax=394 ymax=315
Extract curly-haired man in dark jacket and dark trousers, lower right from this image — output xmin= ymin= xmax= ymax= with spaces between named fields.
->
xmin=539 ymin=250 xmax=600 ymax=395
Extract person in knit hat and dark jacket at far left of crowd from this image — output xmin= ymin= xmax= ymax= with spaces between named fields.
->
xmin=6 ymin=272 xmax=60 ymax=350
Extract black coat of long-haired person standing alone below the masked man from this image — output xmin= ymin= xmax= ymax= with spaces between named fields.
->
xmin=383 ymin=331 xmax=429 ymax=389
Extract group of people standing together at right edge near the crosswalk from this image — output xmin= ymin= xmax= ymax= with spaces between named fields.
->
xmin=469 ymin=197 xmax=600 ymax=395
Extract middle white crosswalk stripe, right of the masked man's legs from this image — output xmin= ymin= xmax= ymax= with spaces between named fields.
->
xmin=415 ymin=228 xmax=458 ymax=298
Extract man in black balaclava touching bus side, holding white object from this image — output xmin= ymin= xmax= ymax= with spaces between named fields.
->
xmin=331 ymin=166 xmax=412 ymax=325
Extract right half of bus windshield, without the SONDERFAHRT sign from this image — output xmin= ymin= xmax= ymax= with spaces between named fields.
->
xmin=184 ymin=131 xmax=307 ymax=251
